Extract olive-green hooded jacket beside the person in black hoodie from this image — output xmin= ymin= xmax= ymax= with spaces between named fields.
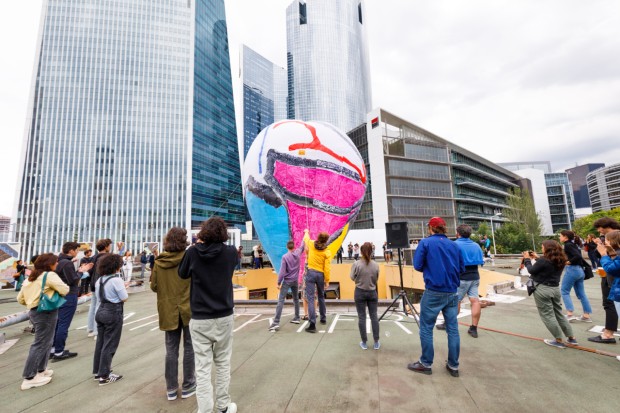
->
xmin=151 ymin=251 xmax=191 ymax=331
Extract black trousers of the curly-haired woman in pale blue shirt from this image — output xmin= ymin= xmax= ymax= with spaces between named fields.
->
xmin=93 ymin=302 xmax=123 ymax=377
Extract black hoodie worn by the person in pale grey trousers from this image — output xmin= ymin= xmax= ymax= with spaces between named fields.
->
xmin=179 ymin=243 xmax=237 ymax=320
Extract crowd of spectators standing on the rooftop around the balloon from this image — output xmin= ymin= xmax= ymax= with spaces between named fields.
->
xmin=10 ymin=212 xmax=620 ymax=413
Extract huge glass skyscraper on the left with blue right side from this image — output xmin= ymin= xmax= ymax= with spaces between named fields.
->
xmin=16 ymin=0 xmax=244 ymax=257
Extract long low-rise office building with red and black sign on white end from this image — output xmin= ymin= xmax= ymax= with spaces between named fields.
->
xmin=348 ymin=109 xmax=520 ymax=239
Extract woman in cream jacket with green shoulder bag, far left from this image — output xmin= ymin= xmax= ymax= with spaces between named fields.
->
xmin=17 ymin=254 xmax=69 ymax=390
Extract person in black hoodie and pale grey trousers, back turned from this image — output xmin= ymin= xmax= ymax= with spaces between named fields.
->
xmin=179 ymin=217 xmax=237 ymax=413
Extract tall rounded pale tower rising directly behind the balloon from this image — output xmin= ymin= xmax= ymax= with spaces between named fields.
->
xmin=286 ymin=0 xmax=372 ymax=132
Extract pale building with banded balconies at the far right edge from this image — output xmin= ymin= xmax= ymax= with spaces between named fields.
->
xmin=586 ymin=163 xmax=620 ymax=212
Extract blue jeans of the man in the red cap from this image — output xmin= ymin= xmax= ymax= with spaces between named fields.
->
xmin=420 ymin=289 xmax=461 ymax=370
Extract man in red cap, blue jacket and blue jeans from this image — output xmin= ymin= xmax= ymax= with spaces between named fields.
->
xmin=407 ymin=217 xmax=465 ymax=377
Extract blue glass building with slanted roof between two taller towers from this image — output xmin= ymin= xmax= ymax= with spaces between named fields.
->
xmin=240 ymin=45 xmax=287 ymax=159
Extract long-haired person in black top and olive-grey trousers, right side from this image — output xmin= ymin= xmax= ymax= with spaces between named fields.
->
xmin=523 ymin=240 xmax=577 ymax=348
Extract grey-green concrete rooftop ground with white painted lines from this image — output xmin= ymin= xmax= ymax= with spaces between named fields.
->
xmin=0 ymin=262 xmax=620 ymax=413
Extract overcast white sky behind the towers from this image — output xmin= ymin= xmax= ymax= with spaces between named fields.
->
xmin=0 ymin=0 xmax=620 ymax=216
